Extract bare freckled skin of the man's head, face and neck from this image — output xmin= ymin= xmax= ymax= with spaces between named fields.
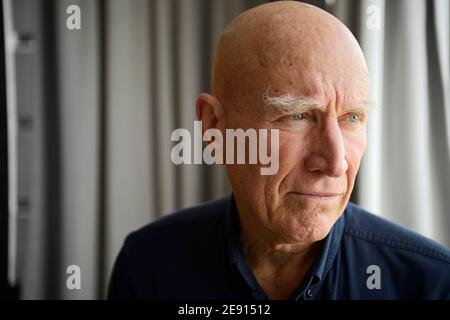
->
xmin=197 ymin=1 xmax=369 ymax=297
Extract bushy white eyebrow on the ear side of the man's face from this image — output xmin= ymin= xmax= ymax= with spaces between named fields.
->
xmin=263 ymin=93 xmax=325 ymax=113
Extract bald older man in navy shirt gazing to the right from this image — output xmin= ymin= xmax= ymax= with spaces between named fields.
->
xmin=108 ymin=1 xmax=450 ymax=300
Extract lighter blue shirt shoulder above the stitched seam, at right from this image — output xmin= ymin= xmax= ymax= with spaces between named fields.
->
xmin=344 ymin=203 xmax=450 ymax=268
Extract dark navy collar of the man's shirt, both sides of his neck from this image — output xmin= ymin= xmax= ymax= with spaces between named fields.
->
xmin=225 ymin=194 xmax=347 ymax=283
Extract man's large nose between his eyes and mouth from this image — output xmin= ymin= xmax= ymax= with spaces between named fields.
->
xmin=306 ymin=119 xmax=348 ymax=177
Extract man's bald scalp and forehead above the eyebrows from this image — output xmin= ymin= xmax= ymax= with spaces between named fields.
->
xmin=212 ymin=1 xmax=368 ymax=109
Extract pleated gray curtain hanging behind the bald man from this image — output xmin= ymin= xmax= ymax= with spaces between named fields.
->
xmin=7 ymin=0 xmax=450 ymax=299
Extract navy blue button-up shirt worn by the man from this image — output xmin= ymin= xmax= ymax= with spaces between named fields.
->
xmin=108 ymin=196 xmax=450 ymax=300
